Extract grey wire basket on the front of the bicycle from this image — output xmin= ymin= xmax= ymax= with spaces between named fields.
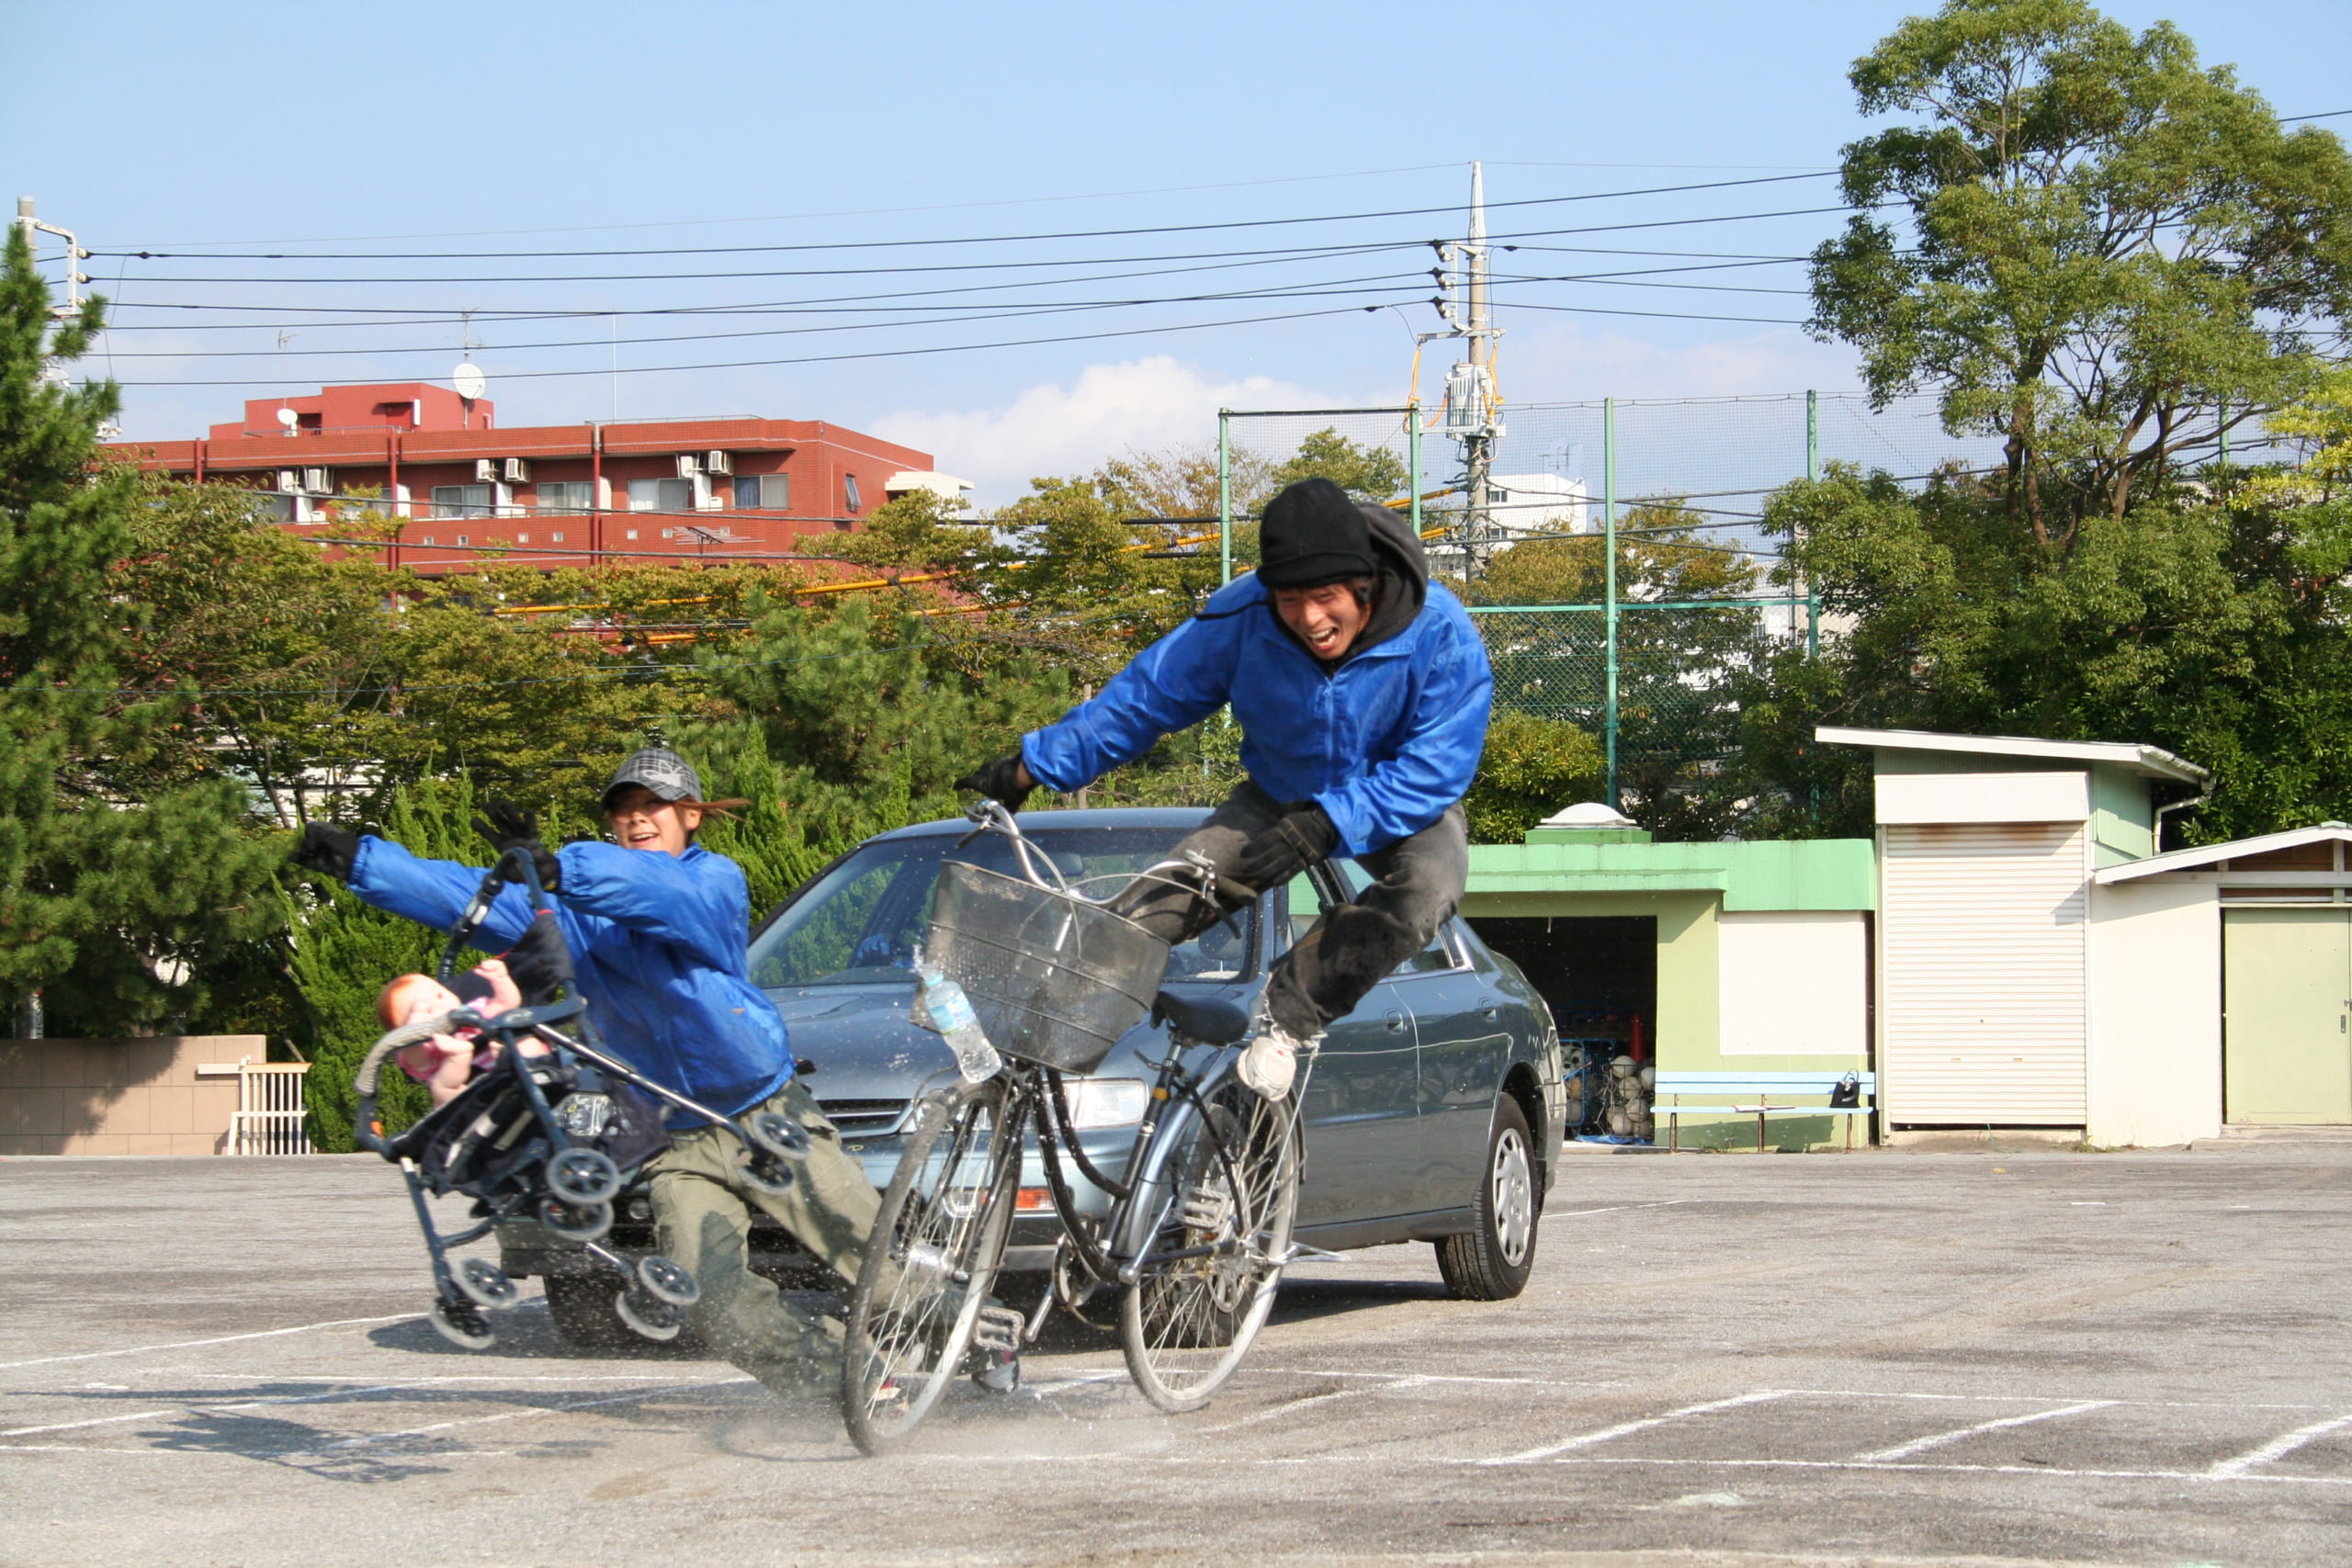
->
xmin=924 ymin=861 xmax=1169 ymax=1072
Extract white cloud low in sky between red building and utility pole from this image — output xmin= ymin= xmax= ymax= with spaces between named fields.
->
xmin=870 ymin=355 xmax=1331 ymax=505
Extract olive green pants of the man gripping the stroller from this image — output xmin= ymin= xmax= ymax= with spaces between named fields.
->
xmin=647 ymin=1084 xmax=882 ymax=1396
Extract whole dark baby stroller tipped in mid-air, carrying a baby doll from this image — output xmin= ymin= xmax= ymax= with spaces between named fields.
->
xmin=353 ymin=849 xmax=809 ymax=1349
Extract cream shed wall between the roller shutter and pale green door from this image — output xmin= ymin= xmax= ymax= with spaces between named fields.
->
xmin=2084 ymin=877 xmax=2221 ymax=1147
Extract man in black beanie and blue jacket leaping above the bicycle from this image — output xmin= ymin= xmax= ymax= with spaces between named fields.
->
xmin=957 ymin=479 xmax=1494 ymax=1100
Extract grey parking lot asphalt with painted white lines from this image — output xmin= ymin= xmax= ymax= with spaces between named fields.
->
xmin=0 ymin=1140 xmax=2352 ymax=1568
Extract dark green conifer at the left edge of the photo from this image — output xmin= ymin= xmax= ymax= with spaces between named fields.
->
xmin=0 ymin=228 xmax=277 ymax=1034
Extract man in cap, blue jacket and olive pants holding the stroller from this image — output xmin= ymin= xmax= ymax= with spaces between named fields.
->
xmin=294 ymin=748 xmax=882 ymax=1394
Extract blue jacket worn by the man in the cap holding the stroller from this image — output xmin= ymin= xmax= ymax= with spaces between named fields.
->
xmin=350 ymin=837 xmax=793 ymax=1126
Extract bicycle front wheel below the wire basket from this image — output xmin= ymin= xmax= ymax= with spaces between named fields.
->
xmin=842 ymin=1075 xmax=1023 ymax=1453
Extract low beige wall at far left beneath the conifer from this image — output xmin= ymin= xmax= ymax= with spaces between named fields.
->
xmin=0 ymin=1034 xmax=268 ymax=1155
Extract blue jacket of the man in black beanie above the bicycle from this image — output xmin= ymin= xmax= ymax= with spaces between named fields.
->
xmin=1021 ymin=534 xmax=1494 ymax=856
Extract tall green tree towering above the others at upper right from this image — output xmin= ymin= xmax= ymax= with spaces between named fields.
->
xmin=1811 ymin=0 xmax=2352 ymax=550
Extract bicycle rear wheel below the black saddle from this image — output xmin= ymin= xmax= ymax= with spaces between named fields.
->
xmin=1120 ymin=1077 xmax=1298 ymax=1413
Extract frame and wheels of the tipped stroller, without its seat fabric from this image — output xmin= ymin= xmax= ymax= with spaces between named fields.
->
xmin=353 ymin=849 xmax=809 ymax=1349
